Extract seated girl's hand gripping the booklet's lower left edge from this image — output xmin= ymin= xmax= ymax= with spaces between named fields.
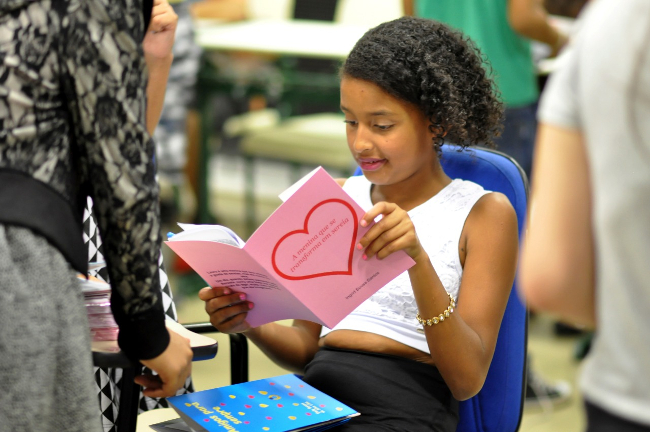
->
xmin=199 ymin=287 xmax=253 ymax=333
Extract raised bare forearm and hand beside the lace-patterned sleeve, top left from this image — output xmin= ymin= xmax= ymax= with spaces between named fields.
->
xmin=142 ymin=0 xmax=178 ymax=135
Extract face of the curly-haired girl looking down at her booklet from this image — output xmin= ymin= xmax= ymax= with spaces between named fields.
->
xmin=341 ymin=77 xmax=437 ymax=186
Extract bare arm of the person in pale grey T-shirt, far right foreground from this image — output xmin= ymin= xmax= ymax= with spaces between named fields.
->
xmin=519 ymin=123 xmax=596 ymax=326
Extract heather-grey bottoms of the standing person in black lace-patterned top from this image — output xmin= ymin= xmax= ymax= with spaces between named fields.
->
xmin=0 ymin=225 xmax=101 ymax=432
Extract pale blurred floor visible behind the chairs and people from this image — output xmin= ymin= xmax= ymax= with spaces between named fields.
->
xmin=158 ymin=156 xmax=584 ymax=432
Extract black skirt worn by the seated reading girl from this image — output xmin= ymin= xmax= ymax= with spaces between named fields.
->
xmin=304 ymin=348 xmax=458 ymax=432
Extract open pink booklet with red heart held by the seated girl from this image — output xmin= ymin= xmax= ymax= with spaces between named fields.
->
xmin=166 ymin=168 xmax=414 ymax=328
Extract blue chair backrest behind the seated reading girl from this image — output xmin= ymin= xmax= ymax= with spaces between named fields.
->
xmin=357 ymin=145 xmax=528 ymax=432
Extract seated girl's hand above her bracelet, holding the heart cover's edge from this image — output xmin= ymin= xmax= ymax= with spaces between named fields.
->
xmin=357 ymin=201 xmax=426 ymax=262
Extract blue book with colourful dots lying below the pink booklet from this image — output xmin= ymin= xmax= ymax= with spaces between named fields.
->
xmin=156 ymin=374 xmax=359 ymax=432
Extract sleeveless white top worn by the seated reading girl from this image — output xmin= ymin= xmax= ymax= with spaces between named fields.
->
xmin=321 ymin=176 xmax=489 ymax=353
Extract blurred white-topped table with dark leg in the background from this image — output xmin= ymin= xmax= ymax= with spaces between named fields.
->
xmin=191 ymin=19 xmax=368 ymax=223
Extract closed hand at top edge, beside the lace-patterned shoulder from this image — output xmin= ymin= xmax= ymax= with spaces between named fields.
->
xmin=142 ymin=0 xmax=178 ymax=59
